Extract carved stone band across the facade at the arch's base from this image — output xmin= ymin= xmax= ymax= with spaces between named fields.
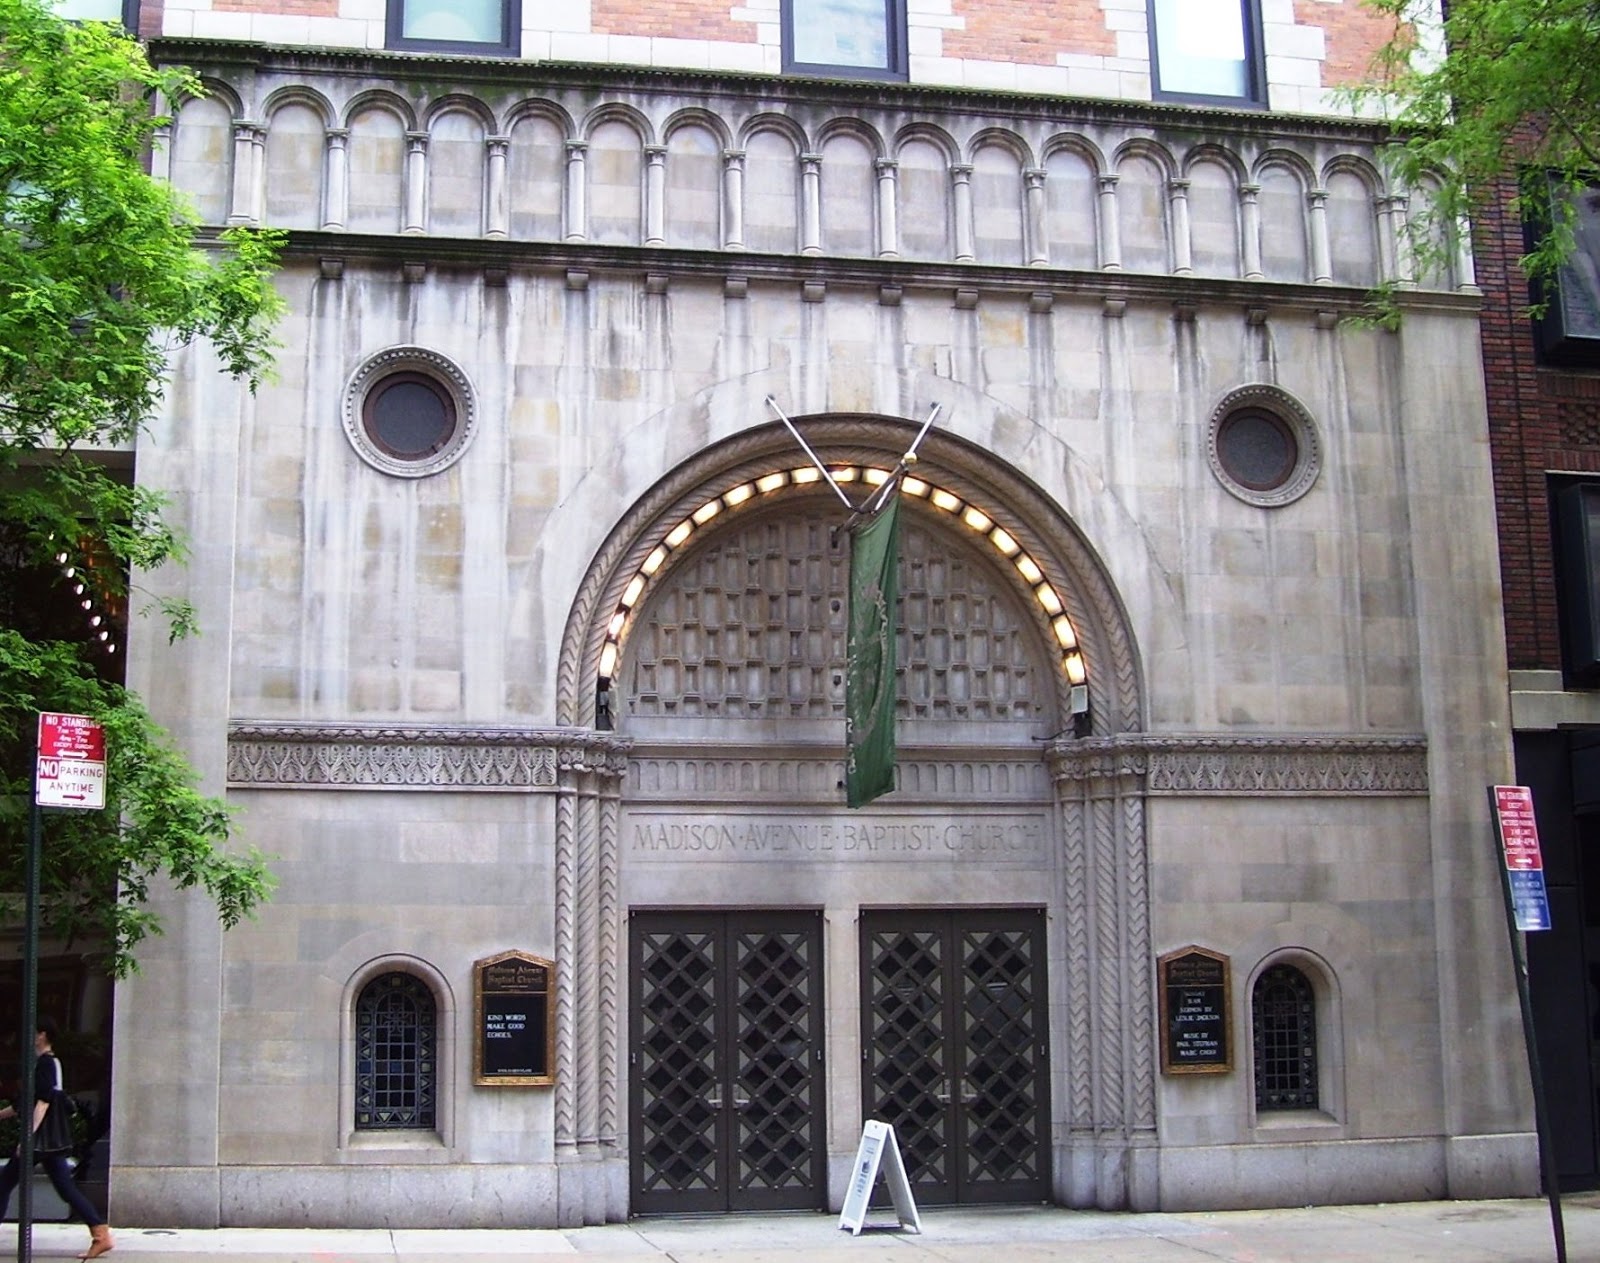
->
xmin=227 ymin=724 xmax=1427 ymax=797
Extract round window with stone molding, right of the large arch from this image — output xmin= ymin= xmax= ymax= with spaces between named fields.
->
xmin=1206 ymin=386 xmax=1322 ymax=509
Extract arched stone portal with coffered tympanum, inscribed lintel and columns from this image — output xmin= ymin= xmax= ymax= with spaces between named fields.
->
xmin=554 ymin=415 xmax=1155 ymax=1217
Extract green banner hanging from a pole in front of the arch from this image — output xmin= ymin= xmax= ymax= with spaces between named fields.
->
xmin=845 ymin=487 xmax=901 ymax=807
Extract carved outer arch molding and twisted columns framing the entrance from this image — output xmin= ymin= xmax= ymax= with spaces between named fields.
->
xmin=555 ymin=416 xmax=1155 ymax=1223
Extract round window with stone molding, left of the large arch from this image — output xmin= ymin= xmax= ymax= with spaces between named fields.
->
xmin=344 ymin=346 xmax=475 ymax=479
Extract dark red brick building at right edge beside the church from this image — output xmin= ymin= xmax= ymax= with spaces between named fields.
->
xmin=1475 ymin=169 xmax=1600 ymax=1188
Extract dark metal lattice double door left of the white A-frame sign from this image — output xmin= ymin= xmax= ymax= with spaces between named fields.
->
xmin=629 ymin=912 xmax=827 ymax=1215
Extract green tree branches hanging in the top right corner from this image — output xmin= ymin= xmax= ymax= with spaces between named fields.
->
xmin=1347 ymin=0 xmax=1600 ymax=305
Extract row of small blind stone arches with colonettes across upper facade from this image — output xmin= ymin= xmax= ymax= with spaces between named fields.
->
xmin=170 ymin=90 xmax=1448 ymax=287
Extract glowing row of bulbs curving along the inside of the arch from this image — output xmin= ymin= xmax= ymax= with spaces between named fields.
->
xmin=595 ymin=464 xmax=1090 ymax=716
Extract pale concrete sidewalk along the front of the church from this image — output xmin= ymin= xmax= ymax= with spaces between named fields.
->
xmin=0 ymin=1194 xmax=1600 ymax=1263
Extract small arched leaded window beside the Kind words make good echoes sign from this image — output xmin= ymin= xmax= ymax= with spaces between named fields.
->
xmin=355 ymin=973 xmax=438 ymax=1132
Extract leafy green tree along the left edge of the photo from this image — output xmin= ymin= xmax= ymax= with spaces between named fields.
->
xmin=0 ymin=0 xmax=282 ymax=976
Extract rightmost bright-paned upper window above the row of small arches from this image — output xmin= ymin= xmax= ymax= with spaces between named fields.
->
xmin=1149 ymin=0 xmax=1267 ymax=106
